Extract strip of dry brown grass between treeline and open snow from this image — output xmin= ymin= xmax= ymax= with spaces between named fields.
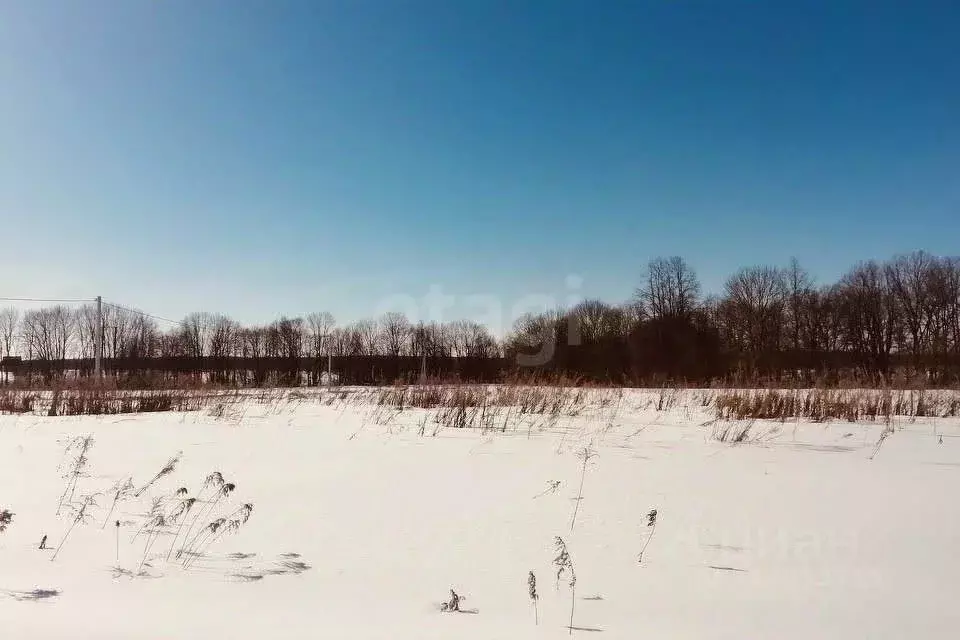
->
xmin=0 ymin=379 xmax=960 ymax=428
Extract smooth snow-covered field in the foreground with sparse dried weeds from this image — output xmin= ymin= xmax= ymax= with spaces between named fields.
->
xmin=0 ymin=391 xmax=960 ymax=640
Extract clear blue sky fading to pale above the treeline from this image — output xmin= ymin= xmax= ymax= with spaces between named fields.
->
xmin=0 ymin=0 xmax=960 ymax=330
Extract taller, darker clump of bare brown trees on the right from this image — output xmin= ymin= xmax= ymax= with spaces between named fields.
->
xmin=505 ymin=252 xmax=960 ymax=384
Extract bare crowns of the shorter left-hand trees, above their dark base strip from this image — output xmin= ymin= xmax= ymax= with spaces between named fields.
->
xmin=0 ymin=304 xmax=500 ymax=361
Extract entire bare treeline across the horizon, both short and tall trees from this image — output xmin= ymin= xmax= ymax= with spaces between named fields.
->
xmin=0 ymin=252 xmax=960 ymax=385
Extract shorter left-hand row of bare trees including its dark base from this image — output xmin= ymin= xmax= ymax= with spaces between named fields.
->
xmin=0 ymin=304 xmax=506 ymax=385
